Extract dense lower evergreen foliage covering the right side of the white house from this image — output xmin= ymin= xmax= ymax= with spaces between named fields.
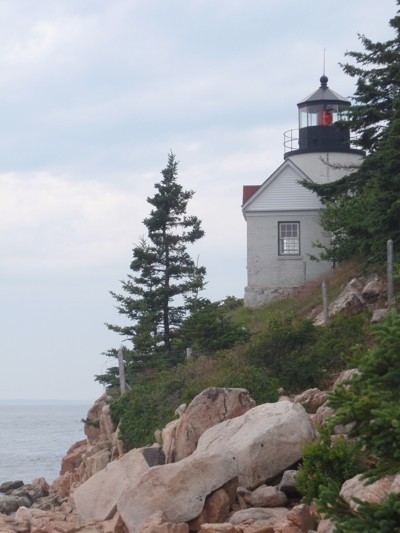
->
xmin=304 ymin=97 xmax=400 ymax=267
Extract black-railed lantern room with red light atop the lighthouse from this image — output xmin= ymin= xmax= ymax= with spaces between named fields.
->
xmin=284 ymin=75 xmax=362 ymax=159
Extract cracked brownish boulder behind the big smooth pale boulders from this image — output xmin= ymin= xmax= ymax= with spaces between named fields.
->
xmin=163 ymin=387 xmax=255 ymax=463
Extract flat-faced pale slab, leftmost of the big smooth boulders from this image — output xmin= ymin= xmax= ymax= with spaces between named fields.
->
xmin=73 ymin=442 xmax=162 ymax=521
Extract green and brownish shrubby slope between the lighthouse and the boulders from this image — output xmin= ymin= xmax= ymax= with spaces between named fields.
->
xmin=111 ymin=263 xmax=376 ymax=450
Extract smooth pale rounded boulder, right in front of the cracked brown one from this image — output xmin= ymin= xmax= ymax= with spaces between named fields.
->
xmin=196 ymin=400 xmax=315 ymax=489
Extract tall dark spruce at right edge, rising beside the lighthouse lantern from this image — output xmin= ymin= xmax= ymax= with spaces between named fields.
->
xmin=303 ymin=0 xmax=400 ymax=266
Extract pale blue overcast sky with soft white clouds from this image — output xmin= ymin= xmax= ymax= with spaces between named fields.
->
xmin=0 ymin=0 xmax=396 ymax=401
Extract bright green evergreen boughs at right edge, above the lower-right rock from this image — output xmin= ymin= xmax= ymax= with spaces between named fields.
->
xmin=329 ymin=310 xmax=400 ymax=478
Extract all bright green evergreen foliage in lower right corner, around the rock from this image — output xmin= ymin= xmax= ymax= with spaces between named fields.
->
xmin=318 ymin=310 xmax=400 ymax=533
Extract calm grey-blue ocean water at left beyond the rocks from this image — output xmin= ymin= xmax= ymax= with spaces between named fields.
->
xmin=0 ymin=401 xmax=91 ymax=484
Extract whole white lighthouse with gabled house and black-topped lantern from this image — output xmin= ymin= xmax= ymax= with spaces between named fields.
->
xmin=242 ymin=75 xmax=364 ymax=307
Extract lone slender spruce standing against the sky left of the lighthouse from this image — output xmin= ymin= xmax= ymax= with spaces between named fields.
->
xmin=101 ymin=153 xmax=206 ymax=384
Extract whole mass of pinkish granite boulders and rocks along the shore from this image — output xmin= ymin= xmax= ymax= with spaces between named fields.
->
xmin=0 ymin=279 xmax=394 ymax=533
